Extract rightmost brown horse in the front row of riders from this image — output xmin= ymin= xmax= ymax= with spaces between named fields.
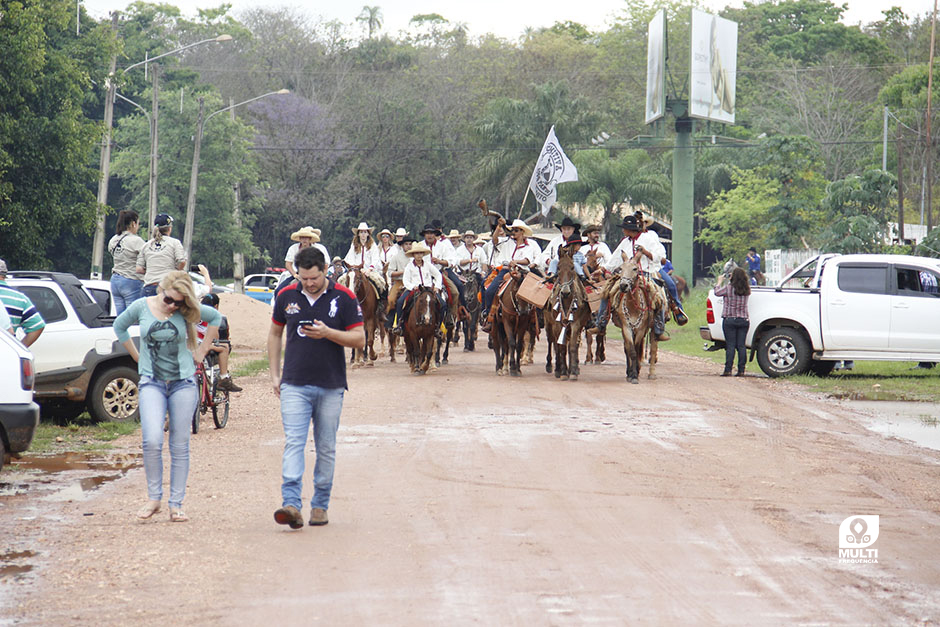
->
xmin=605 ymin=255 xmax=666 ymax=383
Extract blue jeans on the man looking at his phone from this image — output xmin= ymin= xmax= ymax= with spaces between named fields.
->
xmin=281 ymin=383 xmax=345 ymax=509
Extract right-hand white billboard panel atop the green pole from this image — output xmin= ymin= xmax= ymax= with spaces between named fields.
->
xmin=689 ymin=9 xmax=738 ymax=124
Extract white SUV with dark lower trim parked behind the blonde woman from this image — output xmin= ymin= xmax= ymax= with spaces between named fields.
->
xmin=7 ymin=272 xmax=139 ymax=420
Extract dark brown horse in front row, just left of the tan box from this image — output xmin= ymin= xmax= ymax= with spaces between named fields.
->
xmin=490 ymin=269 xmax=538 ymax=377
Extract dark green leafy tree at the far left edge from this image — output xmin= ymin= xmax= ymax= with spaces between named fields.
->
xmin=0 ymin=0 xmax=114 ymax=268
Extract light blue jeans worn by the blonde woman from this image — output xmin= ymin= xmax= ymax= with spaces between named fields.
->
xmin=138 ymin=375 xmax=199 ymax=508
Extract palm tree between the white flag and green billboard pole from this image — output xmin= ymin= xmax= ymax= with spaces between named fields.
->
xmin=558 ymin=149 xmax=670 ymax=243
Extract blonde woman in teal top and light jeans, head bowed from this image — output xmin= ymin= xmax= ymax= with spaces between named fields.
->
xmin=114 ymin=271 xmax=222 ymax=522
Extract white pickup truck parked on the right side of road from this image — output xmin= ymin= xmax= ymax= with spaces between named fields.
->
xmin=700 ymin=254 xmax=940 ymax=377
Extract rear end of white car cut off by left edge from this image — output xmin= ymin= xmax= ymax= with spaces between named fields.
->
xmin=0 ymin=331 xmax=39 ymax=468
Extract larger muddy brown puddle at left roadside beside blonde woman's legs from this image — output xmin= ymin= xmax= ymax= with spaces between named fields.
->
xmin=0 ymin=452 xmax=141 ymax=502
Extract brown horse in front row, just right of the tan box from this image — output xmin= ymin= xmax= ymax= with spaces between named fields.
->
xmin=542 ymin=248 xmax=591 ymax=381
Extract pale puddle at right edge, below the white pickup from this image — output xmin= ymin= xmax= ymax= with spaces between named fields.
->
xmin=846 ymin=401 xmax=940 ymax=451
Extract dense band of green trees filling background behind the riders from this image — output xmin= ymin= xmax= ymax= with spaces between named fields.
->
xmin=0 ymin=0 xmax=940 ymax=275
